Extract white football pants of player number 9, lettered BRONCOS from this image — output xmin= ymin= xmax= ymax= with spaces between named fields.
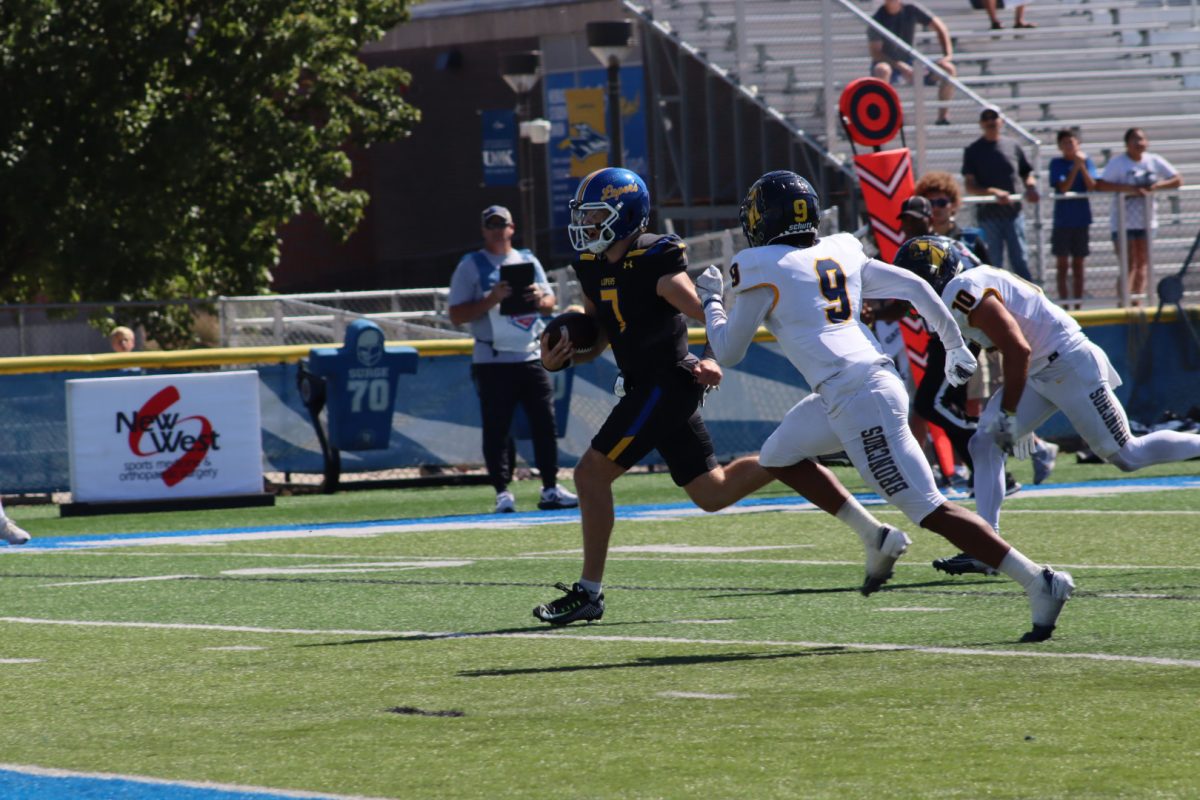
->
xmin=758 ymin=367 xmax=946 ymax=524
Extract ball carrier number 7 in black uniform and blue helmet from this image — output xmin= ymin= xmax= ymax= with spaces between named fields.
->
xmin=533 ymin=167 xmax=921 ymax=625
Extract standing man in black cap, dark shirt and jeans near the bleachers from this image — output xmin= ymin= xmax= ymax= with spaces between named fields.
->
xmin=962 ymin=107 xmax=1038 ymax=281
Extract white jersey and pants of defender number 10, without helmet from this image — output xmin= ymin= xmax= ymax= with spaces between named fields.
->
xmin=942 ymin=266 xmax=1200 ymax=530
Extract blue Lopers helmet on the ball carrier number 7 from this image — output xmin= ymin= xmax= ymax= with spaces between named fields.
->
xmin=566 ymin=167 xmax=650 ymax=253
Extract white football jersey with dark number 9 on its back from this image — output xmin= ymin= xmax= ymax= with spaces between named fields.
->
xmin=730 ymin=234 xmax=892 ymax=390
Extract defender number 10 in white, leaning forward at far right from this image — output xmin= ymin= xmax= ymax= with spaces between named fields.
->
xmin=895 ymin=236 xmax=1200 ymax=530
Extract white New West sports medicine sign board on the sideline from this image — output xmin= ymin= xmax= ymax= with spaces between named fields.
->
xmin=67 ymin=371 xmax=263 ymax=503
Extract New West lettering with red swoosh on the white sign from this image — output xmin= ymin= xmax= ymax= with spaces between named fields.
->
xmin=116 ymin=386 xmax=221 ymax=486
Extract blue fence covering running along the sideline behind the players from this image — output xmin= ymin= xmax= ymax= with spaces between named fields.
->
xmin=0 ymin=323 xmax=1200 ymax=494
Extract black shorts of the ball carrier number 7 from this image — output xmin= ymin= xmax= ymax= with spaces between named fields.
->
xmin=592 ymin=369 xmax=718 ymax=486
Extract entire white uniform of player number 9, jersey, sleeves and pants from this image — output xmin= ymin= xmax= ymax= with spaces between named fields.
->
xmin=704 ymin=234 xmax=962 ymax=524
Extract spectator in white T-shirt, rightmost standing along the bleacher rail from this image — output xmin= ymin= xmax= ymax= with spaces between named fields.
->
xmin=1096 ymin=128 xmax=1183 ymax=306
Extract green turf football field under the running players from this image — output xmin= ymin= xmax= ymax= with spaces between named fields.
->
xmin=0 ymin=456 xmax=1200 ymax=800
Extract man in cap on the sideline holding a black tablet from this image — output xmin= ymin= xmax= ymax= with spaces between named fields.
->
xmin=449 ymin=205 xmax=578 ymax=513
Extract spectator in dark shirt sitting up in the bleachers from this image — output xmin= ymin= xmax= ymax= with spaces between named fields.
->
xmin=866 ymin=0 xmax=958 ymax=125
